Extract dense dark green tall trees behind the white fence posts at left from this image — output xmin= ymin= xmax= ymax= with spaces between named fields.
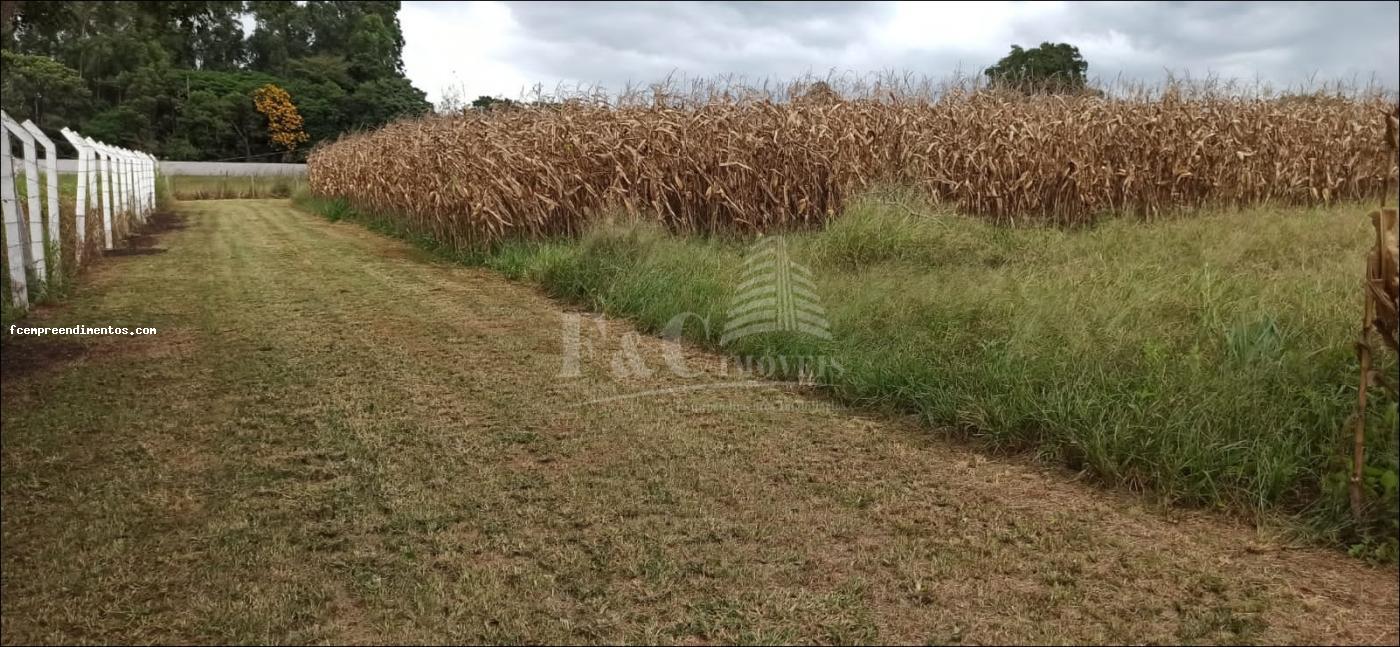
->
xmin=0 ymin=0 xmax=431 ymax=161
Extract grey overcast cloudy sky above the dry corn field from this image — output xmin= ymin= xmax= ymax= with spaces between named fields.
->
xmin=399 ymin=1 xmax=1400 ymax=102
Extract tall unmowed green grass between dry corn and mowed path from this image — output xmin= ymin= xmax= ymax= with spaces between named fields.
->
xmin=298 ymin=191 xmax=1397 ymax=555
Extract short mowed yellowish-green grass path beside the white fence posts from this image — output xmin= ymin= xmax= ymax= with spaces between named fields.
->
xmin=0 ymin=200 xmax=1400 ymax=644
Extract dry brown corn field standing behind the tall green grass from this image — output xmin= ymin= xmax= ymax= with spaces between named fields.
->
xmin=309 ymin=84 xmax=1396 ymax=248
